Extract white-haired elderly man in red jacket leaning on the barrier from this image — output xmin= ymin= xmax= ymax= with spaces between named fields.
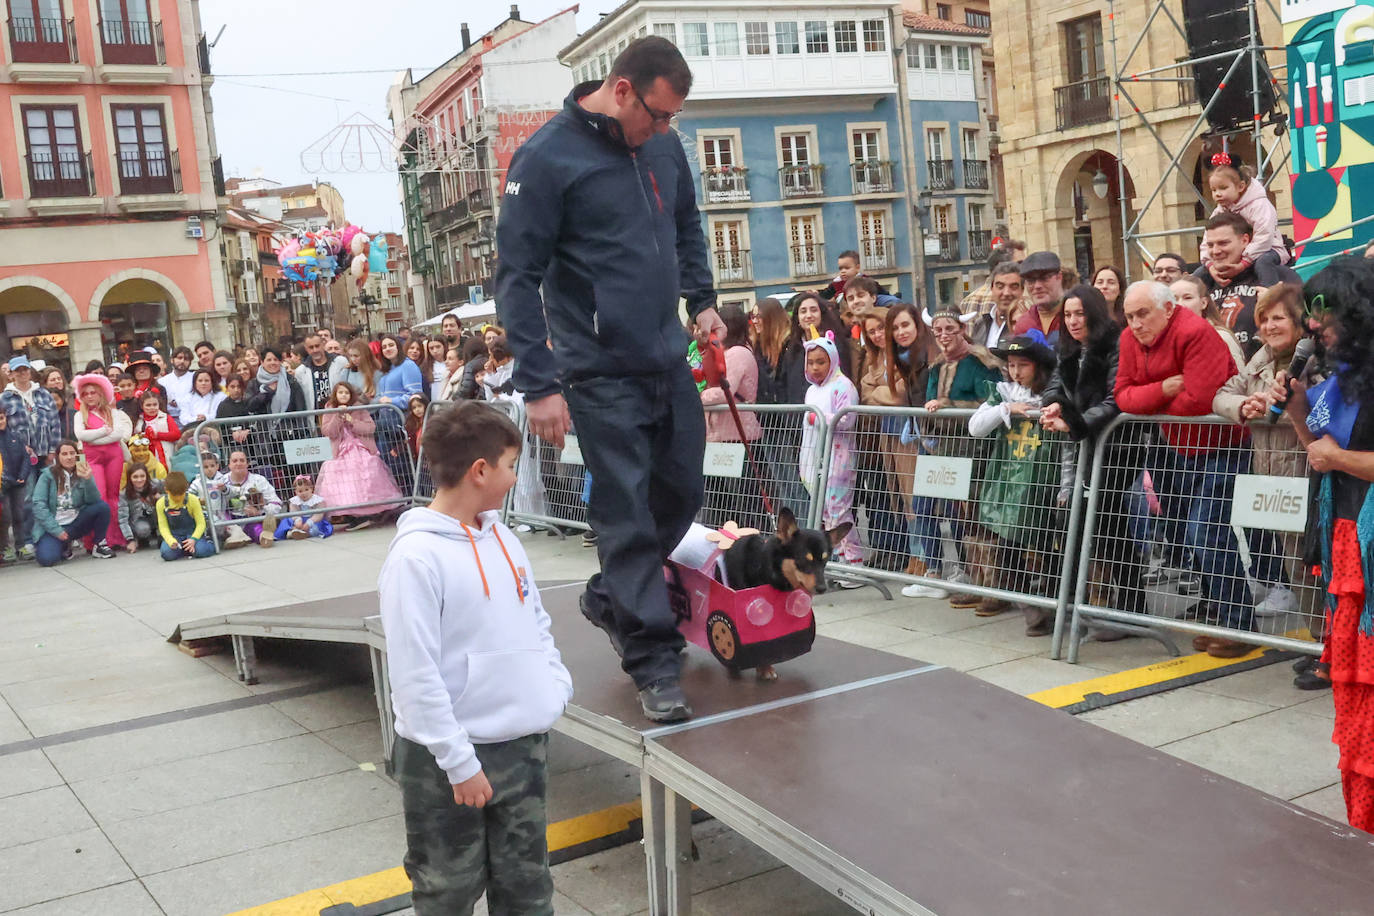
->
xmin=1116 ymin=280 xmax=1253 ymax=658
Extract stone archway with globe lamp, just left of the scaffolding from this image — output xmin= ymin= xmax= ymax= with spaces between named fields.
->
xmin=1057 ymin=150 xmax=1135 ymax=282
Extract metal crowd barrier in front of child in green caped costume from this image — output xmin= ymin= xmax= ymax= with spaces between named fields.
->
xmin=815 ymin=405 xmax=1081 ymax=658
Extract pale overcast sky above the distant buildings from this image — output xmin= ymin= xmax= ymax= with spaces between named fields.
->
xmin=201 ymin=0 xmax=599 ymax=232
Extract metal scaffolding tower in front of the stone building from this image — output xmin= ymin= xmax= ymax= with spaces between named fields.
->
xmin=1107 ymin=0 xmax=1290 ymax=280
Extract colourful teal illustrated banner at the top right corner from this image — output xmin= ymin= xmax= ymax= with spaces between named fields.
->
xmin=1281 ymin=0 xmax=1374 ymax=276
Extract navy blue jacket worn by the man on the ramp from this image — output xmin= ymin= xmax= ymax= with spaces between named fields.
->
xmin=496 ymin=82 xmax=716 ymax=398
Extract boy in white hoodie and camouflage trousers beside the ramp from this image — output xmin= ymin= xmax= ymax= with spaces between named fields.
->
xmin=378 ymin=401 xmax=573 ymax=916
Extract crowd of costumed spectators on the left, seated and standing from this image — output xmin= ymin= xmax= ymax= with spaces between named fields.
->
xmin=0 ymin=316 xmax=511 ymax=566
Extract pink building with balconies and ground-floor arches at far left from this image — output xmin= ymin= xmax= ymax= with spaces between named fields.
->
xmin=0 ymin=0 xmax=234 ymax=369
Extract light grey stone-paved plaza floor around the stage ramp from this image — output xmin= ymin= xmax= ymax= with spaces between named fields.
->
xmin=0 ymin=529 xmax=1345 ymax=916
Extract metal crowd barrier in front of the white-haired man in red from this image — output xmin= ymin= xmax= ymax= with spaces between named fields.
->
xmin=1069 ymin=415 xmax=1325 ymax=662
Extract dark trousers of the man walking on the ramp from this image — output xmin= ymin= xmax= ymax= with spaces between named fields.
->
xmin=563 ymin=360 xmax=706 ymax=688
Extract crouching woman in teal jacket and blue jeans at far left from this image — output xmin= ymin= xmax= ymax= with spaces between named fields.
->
xmin=33 ymin=439 xmax=114 ymax=566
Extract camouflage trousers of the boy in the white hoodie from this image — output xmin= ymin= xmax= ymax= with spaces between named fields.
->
xmin=394 ymin=735 xmax=554 ymax=916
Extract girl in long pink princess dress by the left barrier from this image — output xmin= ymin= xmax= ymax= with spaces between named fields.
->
xmin=315 ymin=382 xmax=401 ymax=531
